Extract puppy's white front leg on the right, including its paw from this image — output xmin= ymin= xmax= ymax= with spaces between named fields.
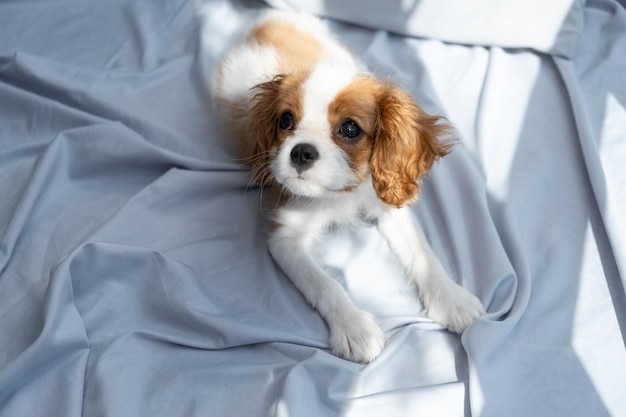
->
xmin=378 ymin=207 xmax=485 ymax=333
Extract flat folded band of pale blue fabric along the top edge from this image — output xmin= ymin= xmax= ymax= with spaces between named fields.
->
xmin=267 ymin=0 xmax=585 ymax=58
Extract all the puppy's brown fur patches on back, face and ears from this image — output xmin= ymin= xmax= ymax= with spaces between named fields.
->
xmin=240 ymin=20 xmax=453 ymax=207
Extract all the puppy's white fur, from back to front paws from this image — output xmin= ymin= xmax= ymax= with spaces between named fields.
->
xmin=214 ymin=13 xmax=484 ymax=363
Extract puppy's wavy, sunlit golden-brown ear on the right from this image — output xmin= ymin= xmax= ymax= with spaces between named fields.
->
xmin=370 ymin=87 xmax=454 ymax=207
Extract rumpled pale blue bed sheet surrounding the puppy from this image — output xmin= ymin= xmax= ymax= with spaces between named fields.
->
xmin=0 ymin=0 xmax=626 ymax=417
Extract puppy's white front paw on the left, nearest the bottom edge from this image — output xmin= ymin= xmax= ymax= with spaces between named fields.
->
xmin=329 ymin=309 xmax=385 ymax=363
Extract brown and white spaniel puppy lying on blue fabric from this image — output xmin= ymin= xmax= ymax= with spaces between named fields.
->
xmin=213 ymin=8 xmax=484 ymax=363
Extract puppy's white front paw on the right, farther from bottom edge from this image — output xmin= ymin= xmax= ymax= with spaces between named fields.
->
xmin=424 ymin=282 xmax=485 ymax=334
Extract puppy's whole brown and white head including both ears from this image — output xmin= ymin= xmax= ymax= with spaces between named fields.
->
xmin=246 ymin=65 xmax=452 ymax=207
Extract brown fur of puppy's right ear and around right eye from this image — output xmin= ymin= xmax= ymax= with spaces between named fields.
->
xmin=329 ymin=76 xmax=453 ymax=207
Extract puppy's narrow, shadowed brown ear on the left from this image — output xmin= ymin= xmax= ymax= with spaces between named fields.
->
xmin=249 ymin=75 xmax=284 ymax=184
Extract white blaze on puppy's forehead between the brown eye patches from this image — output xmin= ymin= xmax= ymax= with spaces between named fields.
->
xmin=300 ymin=62 xmax=358 ymax=131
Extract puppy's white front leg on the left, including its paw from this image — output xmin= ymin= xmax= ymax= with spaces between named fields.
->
xmin=269 ymin=226 xmax=385 ymax=363
